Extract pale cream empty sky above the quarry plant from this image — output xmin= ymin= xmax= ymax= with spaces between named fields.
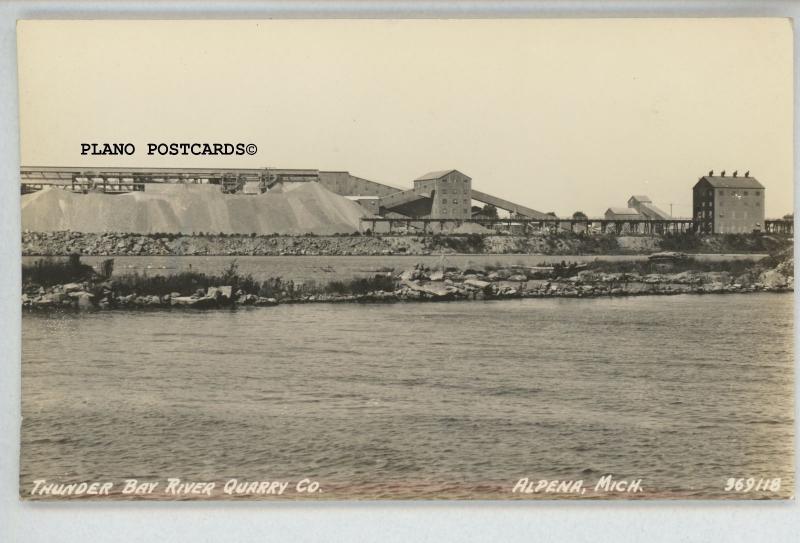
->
xmin=18 ymin=19 xmax=793 ymax=217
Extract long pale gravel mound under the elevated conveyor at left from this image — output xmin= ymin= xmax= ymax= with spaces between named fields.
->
xmin=22 ymin=182 xmax=368 ymax=235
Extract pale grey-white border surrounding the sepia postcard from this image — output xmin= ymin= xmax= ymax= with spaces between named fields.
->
xmin=0 ymin=0 xmax=800 ymax=542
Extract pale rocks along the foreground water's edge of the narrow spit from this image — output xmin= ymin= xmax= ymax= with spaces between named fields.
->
xmin=22 ymin=260 xmax=794 ymax=310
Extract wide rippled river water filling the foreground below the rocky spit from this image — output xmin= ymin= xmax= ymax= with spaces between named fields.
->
xmin=20 ymin=294 xmax=794 ymax=498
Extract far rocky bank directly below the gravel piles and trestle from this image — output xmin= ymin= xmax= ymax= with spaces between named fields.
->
xmin=22 ymin=232 xmax=792 ymax=256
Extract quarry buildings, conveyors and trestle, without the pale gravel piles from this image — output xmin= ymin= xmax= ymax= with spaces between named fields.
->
xmin=20 ymin=167 xmax=793 ymax=234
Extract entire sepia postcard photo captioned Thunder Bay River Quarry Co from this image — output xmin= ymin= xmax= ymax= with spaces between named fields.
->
xmin=14 ymin=17 xmax=796 ymax=502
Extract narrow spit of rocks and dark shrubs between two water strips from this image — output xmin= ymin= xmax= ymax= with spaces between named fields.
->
xmin=22 ymin=248 xmax=794 ymax=309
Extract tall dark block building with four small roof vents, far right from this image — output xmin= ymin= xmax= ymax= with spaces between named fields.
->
xmin=692 ymin=170 xmax=765 ymax=234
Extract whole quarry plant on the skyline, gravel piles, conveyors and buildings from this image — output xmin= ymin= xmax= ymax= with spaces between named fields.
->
xmin=20 ymin=166 xmax=793 ymax=234
